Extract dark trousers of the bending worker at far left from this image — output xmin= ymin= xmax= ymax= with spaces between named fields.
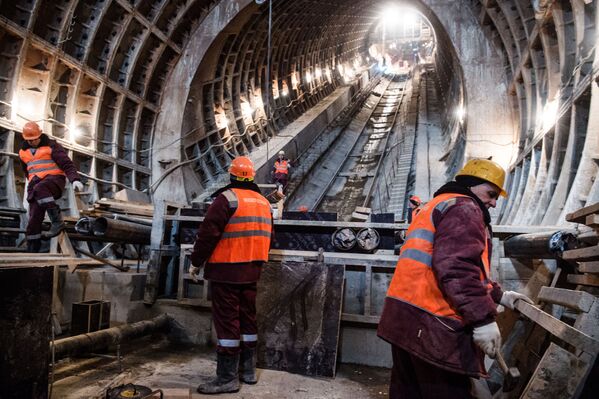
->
xmin=26 ymin=175 xmax=66 ymax=241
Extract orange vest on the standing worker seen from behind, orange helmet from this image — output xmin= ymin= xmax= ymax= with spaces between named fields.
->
xmin=208 ymin=188 xmax=272 ymax=263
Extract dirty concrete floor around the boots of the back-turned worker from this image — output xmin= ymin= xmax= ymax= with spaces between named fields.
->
xmin=52 ymin=338 xmax=390 ymax=399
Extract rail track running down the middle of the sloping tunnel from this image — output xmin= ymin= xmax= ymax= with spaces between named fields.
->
xmin=288 ymin=75 xmax=406 ymax=220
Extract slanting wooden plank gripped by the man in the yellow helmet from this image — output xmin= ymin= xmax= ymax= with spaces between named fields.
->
xmin=516 ymin=300 xmax=599 ymax=355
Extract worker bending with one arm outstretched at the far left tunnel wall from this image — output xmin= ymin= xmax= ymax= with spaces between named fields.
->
xmin=19 ymin=122 xmax=83 ymax=252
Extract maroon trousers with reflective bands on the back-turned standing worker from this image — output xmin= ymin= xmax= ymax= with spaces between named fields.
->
xmin=210 ymin=281 xmax=258 ymax=355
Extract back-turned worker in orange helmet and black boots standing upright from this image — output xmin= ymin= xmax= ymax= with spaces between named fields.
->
xmin=189 ymin=157 xmax=272 ymax=394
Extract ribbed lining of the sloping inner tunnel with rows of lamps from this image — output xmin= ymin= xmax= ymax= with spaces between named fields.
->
xmin=158 ymin=1 xmax=474 ymax=200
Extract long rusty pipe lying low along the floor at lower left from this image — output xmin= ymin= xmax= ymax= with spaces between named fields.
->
xmin=50 ymin=314 xmax=171 ymax=359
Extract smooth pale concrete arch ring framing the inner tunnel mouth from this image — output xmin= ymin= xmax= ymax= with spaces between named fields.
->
xmin=153 ymin=1 xmax=514 ymax=206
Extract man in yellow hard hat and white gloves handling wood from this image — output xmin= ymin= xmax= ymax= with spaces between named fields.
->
xmin=378 ymin=159 xmax=532 ymax=399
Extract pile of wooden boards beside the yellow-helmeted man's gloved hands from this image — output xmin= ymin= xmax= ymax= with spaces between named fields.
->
xmin=493 ymin=203 xmax=599 ymax=399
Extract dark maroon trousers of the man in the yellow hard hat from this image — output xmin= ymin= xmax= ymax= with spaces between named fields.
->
xmin=389 ymin=345 xmax=474 ymax=399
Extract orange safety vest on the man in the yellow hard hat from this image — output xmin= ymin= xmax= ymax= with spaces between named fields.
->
xmin=387 ymin=193 xmax=493 ymax=321
